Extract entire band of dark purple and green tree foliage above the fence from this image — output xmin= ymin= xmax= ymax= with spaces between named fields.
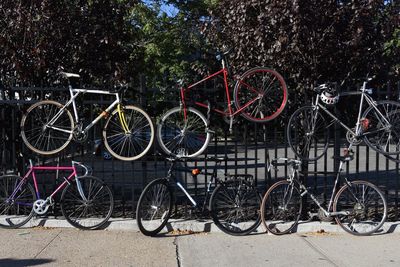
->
xmin=0 ymin=0 xmax=400 ymax=91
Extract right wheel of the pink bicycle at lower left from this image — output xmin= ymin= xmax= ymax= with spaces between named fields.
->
xmin=60 ymin=176 xmax=114 ymax=230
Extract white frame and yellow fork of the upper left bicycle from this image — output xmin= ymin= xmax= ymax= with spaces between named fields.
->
xmin=46 ymin=86 xmax=129 ymax=134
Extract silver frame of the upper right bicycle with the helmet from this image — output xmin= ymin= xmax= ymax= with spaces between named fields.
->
xmin=313 ymin=82 xmax=389 ymax=137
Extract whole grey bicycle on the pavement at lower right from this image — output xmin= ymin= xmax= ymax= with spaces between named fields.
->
xmin=260 ymin=145 xmax=387 ymax=236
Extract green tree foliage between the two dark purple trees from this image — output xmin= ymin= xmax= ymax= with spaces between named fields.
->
xmin=130 ymin=0 xmax=214 ymax=87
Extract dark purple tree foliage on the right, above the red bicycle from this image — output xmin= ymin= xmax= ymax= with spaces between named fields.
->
xmin=210 ymin=0 xmax=400 ymax=88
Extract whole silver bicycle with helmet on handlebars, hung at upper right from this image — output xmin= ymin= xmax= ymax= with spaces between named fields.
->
xmin=287 ymin=81 xmax=400 ymax=160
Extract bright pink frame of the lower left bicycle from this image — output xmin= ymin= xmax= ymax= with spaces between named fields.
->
xmin=9 ymin=161 xmax=89 ymax=202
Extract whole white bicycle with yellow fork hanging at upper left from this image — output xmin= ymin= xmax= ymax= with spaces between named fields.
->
xmin=21 ymin=72 xmax=154 ymax=161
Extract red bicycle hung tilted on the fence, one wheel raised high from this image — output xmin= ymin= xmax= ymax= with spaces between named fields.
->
xmin=157 ymin=50 xmax=288 ymax=157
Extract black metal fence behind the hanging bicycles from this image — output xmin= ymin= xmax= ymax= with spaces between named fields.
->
xmin=0 ymin=83 xmax=400 ymax=220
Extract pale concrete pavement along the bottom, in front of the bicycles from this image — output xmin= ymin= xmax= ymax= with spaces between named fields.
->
xmin=0 ymin=227 xmax=400 ymax=267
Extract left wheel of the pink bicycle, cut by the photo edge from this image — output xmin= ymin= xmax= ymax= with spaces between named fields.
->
xmin=0 ymin=175 xmax=36 ymax=228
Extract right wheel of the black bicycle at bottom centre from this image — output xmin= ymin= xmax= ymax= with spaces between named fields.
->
xmin=210 ymin=180 xmax=261 ymax=235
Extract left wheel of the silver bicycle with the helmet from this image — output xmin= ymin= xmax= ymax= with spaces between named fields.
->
xmin=287 ymin=106 xmax=329 ymax=161
